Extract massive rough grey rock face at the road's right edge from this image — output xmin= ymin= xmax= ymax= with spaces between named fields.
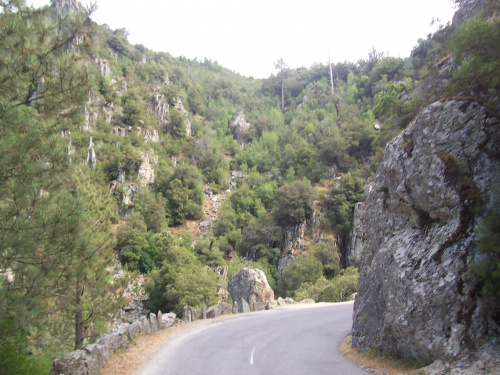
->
xmin=353 ymin=100 xmax=500 ymax=360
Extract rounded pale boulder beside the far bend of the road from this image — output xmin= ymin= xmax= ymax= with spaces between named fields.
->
xmin=228 ymin=268 xmax=274 ymax=307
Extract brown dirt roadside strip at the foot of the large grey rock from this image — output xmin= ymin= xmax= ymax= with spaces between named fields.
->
xmin=339 ymin=335 xmax=423 ymax=375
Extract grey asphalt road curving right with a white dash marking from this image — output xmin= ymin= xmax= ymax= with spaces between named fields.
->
xmin=137 ymin=302 xmax=367 ymax=375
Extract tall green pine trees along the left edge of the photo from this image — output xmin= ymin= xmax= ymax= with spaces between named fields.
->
xmin=0 ymin=0 xmax=121 ymax=360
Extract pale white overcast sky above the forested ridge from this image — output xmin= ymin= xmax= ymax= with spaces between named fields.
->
xmin=27 ymin=0 xmax=455 ymax=78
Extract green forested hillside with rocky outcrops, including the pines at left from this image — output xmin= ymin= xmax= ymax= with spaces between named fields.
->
xmin=0 ymin=0 xmax=499 ymax=374
